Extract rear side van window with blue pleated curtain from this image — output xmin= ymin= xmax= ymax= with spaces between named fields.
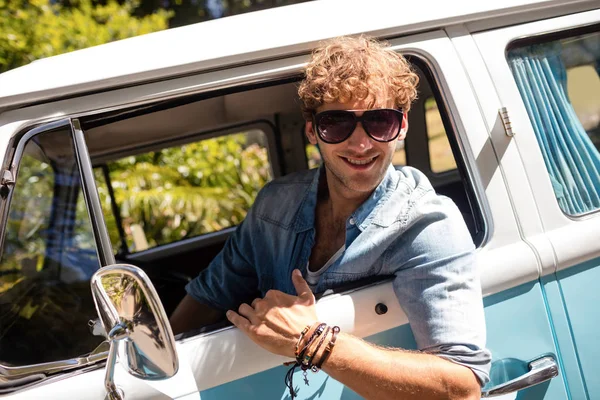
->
xmin=508 ymin=28 xmax=600 ymax=215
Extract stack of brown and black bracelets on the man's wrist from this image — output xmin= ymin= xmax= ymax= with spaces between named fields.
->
xmin=284 ymin=322 xmax=340 ymax=400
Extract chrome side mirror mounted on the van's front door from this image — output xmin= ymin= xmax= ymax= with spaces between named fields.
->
xmin=91 ymin=264 xmax=179 ymax=400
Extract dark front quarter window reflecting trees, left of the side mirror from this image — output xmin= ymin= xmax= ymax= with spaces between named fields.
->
xmin=0 ymin=128 xmax=103 ymax=366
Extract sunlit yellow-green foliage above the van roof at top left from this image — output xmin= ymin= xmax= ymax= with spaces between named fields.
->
xmin=0 ymin=0 xmax=173 ymax=72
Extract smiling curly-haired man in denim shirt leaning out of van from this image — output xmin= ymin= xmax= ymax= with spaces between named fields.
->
xmin=172 ymin=37 xmax=490 ymax=399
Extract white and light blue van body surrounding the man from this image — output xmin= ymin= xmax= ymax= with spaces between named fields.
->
xmin=0 ymin=0 xmax=600 ymax=400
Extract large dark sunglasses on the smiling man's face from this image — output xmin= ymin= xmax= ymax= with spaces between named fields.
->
xmin=313 ymin=108 xmax=404 ymax=144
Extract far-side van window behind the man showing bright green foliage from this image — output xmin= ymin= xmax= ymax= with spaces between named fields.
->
xmin=96 ymin=129 xmax=273 ymax=253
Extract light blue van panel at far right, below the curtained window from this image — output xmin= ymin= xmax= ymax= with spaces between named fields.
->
xmin=556 ymin=258 xmax=600 ymax=399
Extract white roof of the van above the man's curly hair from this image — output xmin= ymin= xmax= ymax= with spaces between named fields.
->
xmin=0 ymin=0 xmax=592 ymax=110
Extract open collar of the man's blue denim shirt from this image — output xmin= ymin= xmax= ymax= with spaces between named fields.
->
xmin=295 ymin=164 xmax=400 ymax=233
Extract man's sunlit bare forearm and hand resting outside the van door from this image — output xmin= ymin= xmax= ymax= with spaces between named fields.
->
xmin=227 ymin=270 xmax=480 ymax=400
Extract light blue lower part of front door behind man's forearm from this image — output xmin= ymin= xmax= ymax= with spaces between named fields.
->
xmin=200 ymin=281 xmax=568 ymax=400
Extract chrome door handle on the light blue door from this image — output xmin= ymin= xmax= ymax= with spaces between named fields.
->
xmin=481 ymin=356 xmax=558 ymax=398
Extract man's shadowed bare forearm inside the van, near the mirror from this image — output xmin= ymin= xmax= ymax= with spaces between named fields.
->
xmin=170 ymin=294 xmax=223 ymax=335
